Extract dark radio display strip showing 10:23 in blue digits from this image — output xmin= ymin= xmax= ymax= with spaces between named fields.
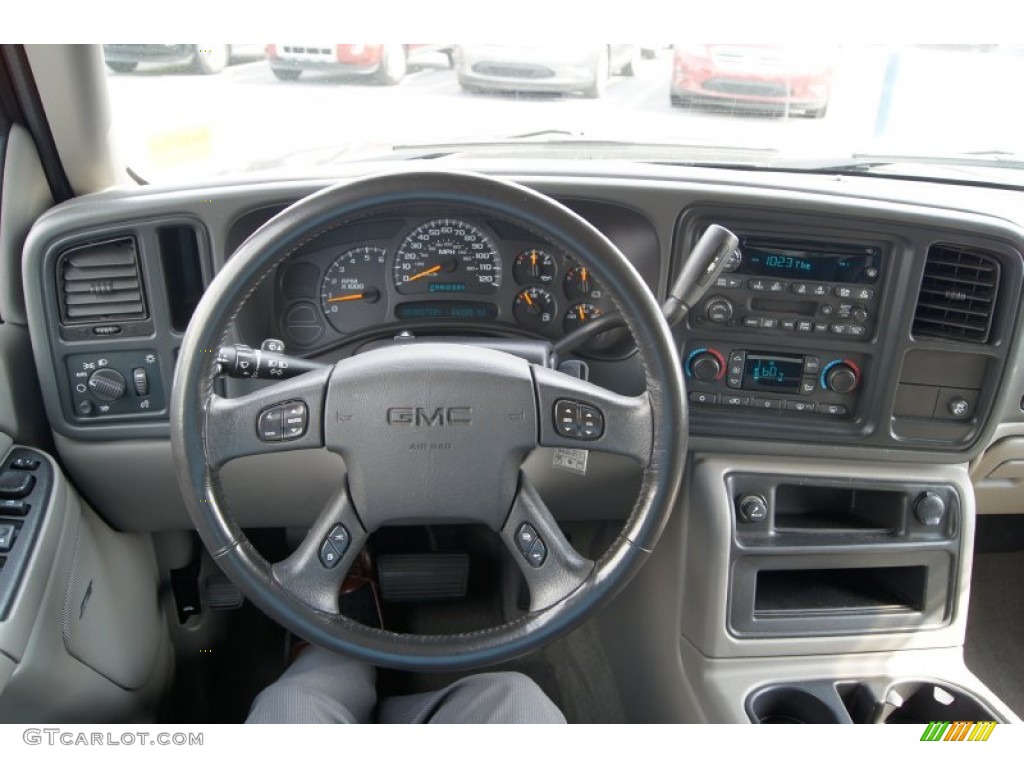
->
xmin=737 ymin=239 xmax=882 ymax=284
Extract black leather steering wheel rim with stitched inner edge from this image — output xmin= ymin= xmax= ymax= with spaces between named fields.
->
xmin=170 ymin=171 xmax=687 ymax=671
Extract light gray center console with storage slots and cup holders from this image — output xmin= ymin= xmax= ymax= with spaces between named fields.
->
xmin=679 ymin=456 xmax=1016 ymax=724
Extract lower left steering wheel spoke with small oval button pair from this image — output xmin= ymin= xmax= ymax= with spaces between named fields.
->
xmin=270 ymin=487 xmax=368 ymax=613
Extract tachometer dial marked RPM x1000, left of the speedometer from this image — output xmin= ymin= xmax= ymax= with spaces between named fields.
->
xmin=321 ymin=246 xmax=387 ymax=333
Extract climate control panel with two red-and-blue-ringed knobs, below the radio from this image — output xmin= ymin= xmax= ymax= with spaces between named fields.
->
xmin=683 ymin=341 xmax=865 ymax=418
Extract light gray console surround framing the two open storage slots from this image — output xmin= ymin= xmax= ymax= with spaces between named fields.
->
xmin=680 ymin=455 xmax=975 ymax=657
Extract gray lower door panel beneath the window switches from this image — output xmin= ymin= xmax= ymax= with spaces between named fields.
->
xmin=0 ymin=442 xmax=172 ymax=722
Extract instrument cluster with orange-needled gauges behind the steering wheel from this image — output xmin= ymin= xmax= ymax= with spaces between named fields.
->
xmin=275 ymin=216 xmax=621 ymax=352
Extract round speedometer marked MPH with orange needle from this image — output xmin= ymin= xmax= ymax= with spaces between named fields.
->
xmin=393 ymin=219 xmax=502 ymax=294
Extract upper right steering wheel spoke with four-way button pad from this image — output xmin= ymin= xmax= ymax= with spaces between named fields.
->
xmin=532 ymin=366 xmax=652 ymax=467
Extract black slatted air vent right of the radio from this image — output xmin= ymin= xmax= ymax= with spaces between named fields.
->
xmin=913 ymin=245 xmax=999 ymax=344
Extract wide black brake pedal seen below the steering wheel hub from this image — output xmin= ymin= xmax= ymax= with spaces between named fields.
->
xmin=377 ymin=552 xmax=469 ymax=603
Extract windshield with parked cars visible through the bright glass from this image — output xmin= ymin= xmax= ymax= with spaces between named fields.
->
xmin=102 ymin=40 xmax=1024 ymax=185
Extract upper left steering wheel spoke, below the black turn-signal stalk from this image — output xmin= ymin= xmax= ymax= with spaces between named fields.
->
xmin=199 ymin=368 xmax=331 ymax=469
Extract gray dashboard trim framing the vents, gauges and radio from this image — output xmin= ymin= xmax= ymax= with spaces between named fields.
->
xmin=18 ymin=163 xmax=1024 ymax=507
